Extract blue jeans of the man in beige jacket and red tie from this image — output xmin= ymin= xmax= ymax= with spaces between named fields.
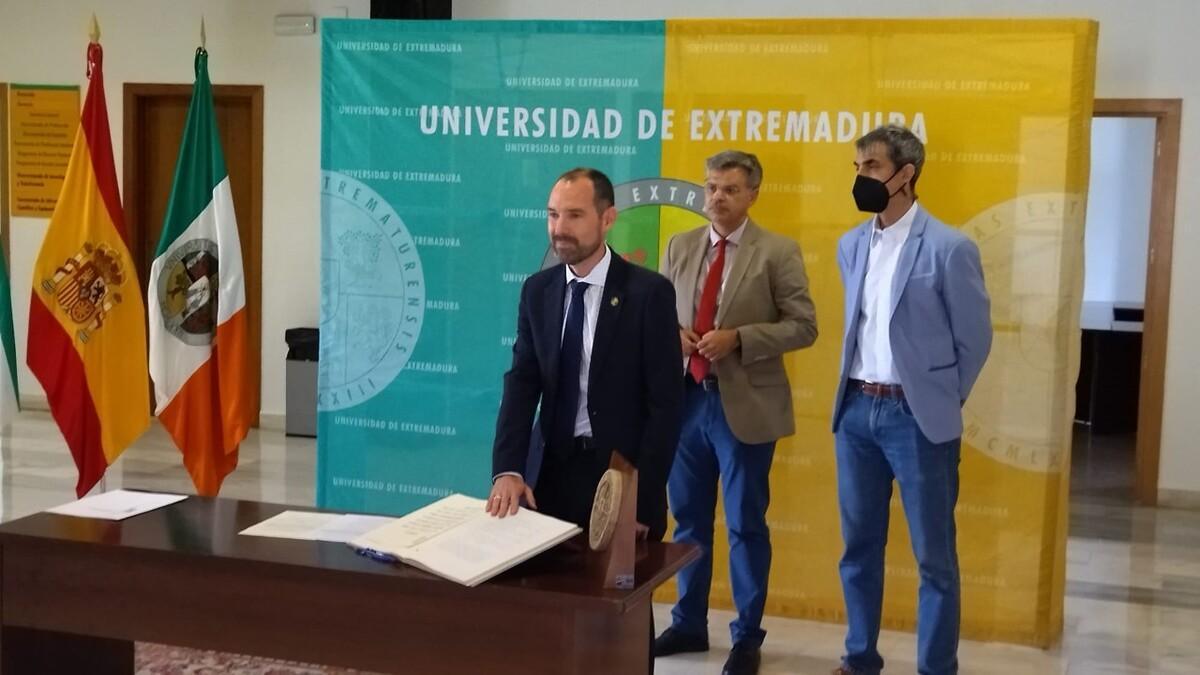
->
xmin=667 ymin=383 xmax=775 ymax=646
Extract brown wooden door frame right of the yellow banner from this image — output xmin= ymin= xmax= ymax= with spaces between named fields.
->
xmin=1092 ymin=98 xmax=1183 ymax=506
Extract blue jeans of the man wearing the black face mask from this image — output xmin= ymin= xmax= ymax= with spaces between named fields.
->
xmin=835 ymin=389 xmax=960 ymax=675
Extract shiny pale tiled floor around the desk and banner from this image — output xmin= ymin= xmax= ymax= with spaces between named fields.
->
xmin=0 ymin=412 xmax=1200 ymax=675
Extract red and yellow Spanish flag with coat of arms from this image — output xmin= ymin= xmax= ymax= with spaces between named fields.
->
xmin=26 ymin=37 xmax=150 ymax=497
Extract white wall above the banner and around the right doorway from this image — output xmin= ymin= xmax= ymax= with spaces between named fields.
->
xmin=454 ymin=0 xmax=1200 ymax=491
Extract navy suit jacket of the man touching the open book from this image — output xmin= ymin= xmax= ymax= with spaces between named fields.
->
xmin=492 ymin=247 xmax=684 ymax=530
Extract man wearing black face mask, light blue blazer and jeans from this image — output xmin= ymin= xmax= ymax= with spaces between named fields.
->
xmin=833 ymin=125 xmax=991 ymax=675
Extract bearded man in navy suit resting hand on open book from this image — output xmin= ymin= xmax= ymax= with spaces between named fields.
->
xmin=488 ymin=168 xmax=683 ymax=539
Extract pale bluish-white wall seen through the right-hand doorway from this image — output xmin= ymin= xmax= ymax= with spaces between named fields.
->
xmin=1084 ymin=118 xmax=1156 ymax=303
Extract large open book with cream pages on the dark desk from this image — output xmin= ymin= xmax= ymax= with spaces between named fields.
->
xmin=349 ymin=495 xmax=582 ymax=586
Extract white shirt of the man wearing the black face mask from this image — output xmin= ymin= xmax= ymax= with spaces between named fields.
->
xmin=850 ymin=202 xmax=917 ymax=384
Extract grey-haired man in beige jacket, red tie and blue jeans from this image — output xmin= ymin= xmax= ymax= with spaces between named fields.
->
xmin=654 ymin=150 xmax=817 ymax=675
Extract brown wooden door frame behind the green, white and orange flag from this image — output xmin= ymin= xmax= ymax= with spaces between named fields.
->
xmin=121 ymin=82 xmax=263 ymax=426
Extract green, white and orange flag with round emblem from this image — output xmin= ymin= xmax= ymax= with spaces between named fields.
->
xmin=148 ymin=47 xmax=258 ymax=496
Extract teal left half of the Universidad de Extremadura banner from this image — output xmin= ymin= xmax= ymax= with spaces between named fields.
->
xmin=317 ymin=20 xmax=665 ymax=513
